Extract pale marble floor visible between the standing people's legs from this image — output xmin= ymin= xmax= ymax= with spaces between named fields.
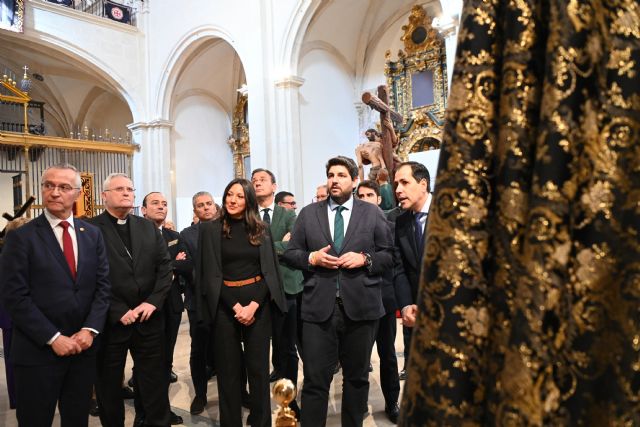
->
xmin=0 ymin=313 xmax=404 ymax=427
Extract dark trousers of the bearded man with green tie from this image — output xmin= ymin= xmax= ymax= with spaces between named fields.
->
xmin=301 ymin=303 xmax=378 ymax=427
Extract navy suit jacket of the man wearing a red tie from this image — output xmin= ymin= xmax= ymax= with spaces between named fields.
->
xmin=0 ymin=214 xmax=110 ymax=365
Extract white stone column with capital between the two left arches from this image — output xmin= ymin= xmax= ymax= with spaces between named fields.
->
xmin=128 ymin=119 xmax=176 ymax=214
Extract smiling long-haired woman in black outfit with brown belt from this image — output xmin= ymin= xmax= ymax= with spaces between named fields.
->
xmin=197 ymin=178 xmax=286 ymax=427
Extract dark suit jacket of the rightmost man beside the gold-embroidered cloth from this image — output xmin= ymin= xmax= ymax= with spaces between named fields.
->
xmin=394 ymin=210 xmax=427 ymax=309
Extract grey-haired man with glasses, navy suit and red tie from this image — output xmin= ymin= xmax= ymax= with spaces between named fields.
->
xmin=0 ymin=165 xmax=109 ymax=426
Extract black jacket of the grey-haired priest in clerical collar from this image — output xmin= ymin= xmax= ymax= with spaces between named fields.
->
xmin=90 ymin=211 xmax=172 ymax=327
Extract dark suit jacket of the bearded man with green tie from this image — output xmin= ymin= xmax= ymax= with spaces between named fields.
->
xmin=283 ymin=199 xmax=393 ymax=322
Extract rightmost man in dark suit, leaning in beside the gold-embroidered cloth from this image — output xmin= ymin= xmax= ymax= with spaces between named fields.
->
xmin=394 ymin=162 xmax=431 ymax=380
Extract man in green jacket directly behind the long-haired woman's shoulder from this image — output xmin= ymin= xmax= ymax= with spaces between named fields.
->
xmin=251 ymin=169 xmax=302 ymax=415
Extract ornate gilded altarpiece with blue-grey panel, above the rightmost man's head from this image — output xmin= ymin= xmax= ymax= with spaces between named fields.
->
xmin=385 ymin=6 xmax=448 ymax=160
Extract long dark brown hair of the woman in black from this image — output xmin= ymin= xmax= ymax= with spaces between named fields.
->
xmin=220 ymin=178 xmax=267 ymax=246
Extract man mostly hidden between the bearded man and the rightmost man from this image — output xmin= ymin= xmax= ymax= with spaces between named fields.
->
xmin=356 ymin=181 xmax=400 ymax=424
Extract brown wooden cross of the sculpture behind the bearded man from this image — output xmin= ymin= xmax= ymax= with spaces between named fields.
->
xmin=362 ymin=85 xmax=403 ymax=181
